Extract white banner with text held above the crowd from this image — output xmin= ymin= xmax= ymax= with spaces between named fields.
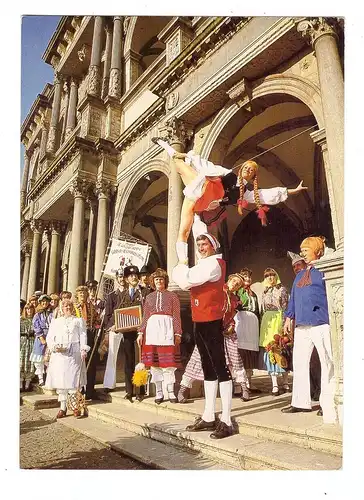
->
xmin=104 ymin=238 xmax=151 ymax=278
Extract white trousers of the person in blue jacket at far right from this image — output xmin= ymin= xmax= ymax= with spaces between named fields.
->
xmin=291 ymin=325 xmax=336 ymax=423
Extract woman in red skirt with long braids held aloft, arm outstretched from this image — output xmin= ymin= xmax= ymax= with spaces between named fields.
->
xmin=152 ymin=137 xmax=307 ymax=263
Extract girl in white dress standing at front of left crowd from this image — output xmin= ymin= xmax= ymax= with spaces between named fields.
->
xmin=46 ymin=299 xmax=90 ymax=418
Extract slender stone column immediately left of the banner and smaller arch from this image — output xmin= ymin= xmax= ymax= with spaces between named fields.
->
xmin=94 ymin=181 xmax=113 ymax=281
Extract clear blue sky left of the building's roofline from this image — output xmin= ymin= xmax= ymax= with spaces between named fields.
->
xmin=20 ymin=16 xmax=61 ymax=170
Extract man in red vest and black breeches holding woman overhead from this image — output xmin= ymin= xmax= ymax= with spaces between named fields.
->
xmin=172 ymin=232 xmax=232 ymax=439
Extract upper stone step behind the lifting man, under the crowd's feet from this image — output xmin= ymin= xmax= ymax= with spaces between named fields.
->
xmin=97 ymin=387 xmax=342 ymax=456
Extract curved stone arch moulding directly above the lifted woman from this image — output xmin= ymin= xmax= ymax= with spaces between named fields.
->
xmin=200 ymin=74 xmax=324 ymax=158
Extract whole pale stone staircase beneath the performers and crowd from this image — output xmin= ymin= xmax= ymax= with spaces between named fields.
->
xmin=23 ymin=379 xmax=342 ymax=470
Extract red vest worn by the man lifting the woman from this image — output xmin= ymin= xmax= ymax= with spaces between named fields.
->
xmin=190 ymin=259 xmax=226 ymax=323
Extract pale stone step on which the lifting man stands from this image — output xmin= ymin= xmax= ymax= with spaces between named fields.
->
xmin=82 ymin=401 xmax=342 ymax=470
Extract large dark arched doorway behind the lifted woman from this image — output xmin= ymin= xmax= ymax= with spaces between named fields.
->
xmin=201 ymin=75 xmax=334 ymax=285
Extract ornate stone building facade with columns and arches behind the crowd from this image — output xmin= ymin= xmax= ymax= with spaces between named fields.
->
xmin=21 ymin=16 xmax=344 ymax=421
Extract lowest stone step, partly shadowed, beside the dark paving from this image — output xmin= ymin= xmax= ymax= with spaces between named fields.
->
xmin=40 ymin=409 xmax=230 ymax=470
